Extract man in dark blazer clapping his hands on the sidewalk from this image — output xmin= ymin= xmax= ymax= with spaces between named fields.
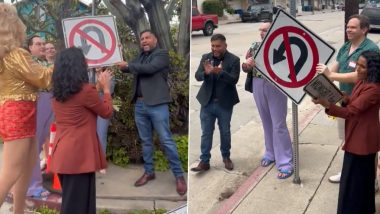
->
xmin=191 ymin=34 xmax=240 ymax=172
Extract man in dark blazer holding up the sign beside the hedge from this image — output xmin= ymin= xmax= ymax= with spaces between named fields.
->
xmin=119 ymin=30 xmax=187 ymax=195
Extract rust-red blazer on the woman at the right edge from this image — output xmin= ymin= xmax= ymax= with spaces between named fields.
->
xmin=326 ymin=81 xmax=380 ymax=155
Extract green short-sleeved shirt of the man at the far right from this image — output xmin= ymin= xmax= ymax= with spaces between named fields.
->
xmin=336 ymin=38 xmax=380 ymax=95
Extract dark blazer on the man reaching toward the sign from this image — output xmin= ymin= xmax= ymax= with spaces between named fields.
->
xmin=122 ymin=48 xmax=172 ymax=105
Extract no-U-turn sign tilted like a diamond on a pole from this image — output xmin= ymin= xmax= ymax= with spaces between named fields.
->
xmin=255 ymin=10 xmax=335 ymax=104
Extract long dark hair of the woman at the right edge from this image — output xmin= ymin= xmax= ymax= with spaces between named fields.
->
xmin=360 ymin=51 xmax=380 ymax=83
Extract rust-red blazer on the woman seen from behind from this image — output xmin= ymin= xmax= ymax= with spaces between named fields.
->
xmin=51 ymin=84 xmax=112 ymax=174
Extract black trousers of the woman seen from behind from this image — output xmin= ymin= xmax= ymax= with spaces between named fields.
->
xmin=58 ymin=172 xmax=96 ymax=214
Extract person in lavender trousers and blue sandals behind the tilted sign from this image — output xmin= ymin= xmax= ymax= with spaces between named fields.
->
xmin=242 ymin=22 xmax=293 ymax=179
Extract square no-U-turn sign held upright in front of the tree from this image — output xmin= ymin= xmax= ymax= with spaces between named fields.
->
xmin=62 ymin=16 xmax=123 ymax=67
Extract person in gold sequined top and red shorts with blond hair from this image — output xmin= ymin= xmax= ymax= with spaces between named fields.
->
xmin=0 ymin=3 xmax=52 ymax=214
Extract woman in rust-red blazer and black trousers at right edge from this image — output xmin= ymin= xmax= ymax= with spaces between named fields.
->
xmin=313 ymin=51 xmax=380 ymax=214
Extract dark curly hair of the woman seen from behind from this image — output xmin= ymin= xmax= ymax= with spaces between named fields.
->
xmin=53 ymin=47 xmax=88 ymax=102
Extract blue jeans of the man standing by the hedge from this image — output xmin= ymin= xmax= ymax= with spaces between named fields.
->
xmin=135 ymin=99 xmax=183 ymax=178
